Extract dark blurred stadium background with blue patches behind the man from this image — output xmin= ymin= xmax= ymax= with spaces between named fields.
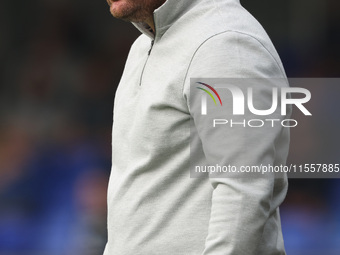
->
xmin=0 ymin=0 xmax=340 ymax=255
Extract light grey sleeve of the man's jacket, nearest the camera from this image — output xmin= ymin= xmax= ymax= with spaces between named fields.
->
xmin=184 ymin=32 xmax=289 ymax=255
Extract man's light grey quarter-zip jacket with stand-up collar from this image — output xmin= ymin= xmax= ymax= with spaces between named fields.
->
xmin=104 ymin=0 xmax=289 ymax=255
